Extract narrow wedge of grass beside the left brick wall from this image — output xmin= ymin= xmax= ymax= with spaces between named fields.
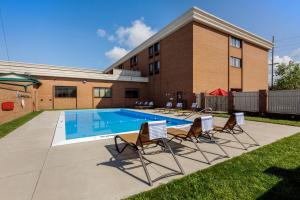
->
xmin=0 ymin=111 xmax=42 ymax=138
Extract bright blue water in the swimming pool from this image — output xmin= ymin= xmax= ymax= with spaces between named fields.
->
xmin=65 ymin=109 xmax=191 ymax=140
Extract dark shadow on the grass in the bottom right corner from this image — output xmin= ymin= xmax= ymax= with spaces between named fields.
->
xmin=258 ymin=167 xmax=300 ymax=200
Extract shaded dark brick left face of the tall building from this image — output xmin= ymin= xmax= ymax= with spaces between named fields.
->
xmin=115 ymin=23 xmax=194 ymax=106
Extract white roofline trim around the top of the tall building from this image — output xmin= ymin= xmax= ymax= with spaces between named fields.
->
xmin=104 ymin=7 xmax=273 ymax=73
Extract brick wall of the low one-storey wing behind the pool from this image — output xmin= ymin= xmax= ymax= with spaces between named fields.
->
xmin=37 ymin=77 xmax=149 ymax=109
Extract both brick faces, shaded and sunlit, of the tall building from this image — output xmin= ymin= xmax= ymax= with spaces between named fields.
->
xmin=115 ymin=22 xmax=268 ymax=106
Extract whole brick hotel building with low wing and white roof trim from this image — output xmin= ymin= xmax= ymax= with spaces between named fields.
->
xmin=0 ymin=7 xmax=273 ymax=122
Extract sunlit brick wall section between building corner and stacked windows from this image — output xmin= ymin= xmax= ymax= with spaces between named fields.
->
xmin=193 ymin=22 xmax=228 ymax=93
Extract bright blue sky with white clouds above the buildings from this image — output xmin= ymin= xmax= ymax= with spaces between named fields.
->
xmin=0 ymin=0 xmax=300 ymax=69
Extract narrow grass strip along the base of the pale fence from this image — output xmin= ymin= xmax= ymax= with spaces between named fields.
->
xmin=214 ymin=114 xmax=300 ymax=126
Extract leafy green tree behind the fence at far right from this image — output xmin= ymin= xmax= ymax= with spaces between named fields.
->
xmin=274 ymin=61 xmax=300 ymax=90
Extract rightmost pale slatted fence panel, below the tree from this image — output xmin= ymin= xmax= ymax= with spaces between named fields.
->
xmin=268 ymin=90 xmax=300 ymax=114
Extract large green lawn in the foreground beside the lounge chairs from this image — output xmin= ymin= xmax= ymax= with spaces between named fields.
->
xmin=128 ymin=133 xmax=300 ymax=200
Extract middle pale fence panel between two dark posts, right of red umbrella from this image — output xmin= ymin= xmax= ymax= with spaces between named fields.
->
xmin=233 ymin=92 xmax=259 ymax=112
